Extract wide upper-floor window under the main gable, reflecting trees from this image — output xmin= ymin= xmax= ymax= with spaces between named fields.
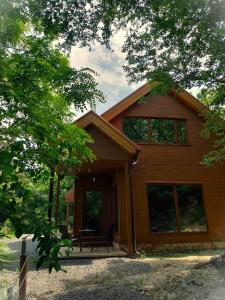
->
xmin=123 ymin=117 xmax=188 ymax=145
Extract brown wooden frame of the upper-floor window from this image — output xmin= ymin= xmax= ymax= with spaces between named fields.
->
xmin=122 ymin=116 xmax=190 ymax=146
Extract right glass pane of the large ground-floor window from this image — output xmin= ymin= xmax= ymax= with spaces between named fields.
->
xmin=177 ymin=184 xmax=207 ymax=232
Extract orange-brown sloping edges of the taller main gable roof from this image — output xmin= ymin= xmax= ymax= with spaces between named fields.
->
xmin=101 ymin=83 xmax=207 ymax=122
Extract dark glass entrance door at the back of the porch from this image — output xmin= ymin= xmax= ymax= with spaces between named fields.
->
xmin=83 ymin=191 xmax=103 ymax=233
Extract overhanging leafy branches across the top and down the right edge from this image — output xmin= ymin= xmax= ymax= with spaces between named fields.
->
xmin=29 ymin=0 xmax=225 ymax=165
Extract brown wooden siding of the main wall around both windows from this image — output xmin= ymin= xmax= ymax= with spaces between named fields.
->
xmin=111 ymin=96 xmax=225 ymax=245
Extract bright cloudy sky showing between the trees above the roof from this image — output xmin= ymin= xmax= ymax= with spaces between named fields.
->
xmin=70 ymin=31 xmax=198 ymax=117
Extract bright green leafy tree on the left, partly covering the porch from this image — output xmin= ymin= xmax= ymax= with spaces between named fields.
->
xmin=0 ymin=0 xmax=104 ymax=271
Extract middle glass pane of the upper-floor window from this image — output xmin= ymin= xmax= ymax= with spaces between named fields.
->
xmin=151 ymin=119 xmax=176 ymax=144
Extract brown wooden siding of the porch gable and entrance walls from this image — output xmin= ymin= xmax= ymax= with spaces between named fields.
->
xmin=74 ymin=125 xmax=131 ymax=245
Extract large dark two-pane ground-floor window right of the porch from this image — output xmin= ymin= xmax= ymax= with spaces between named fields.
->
xmin=148 ymin=184 xmax=207 ymax=232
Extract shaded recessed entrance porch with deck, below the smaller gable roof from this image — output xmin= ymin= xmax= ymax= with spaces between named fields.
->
xmin=65 ymin=160 xmax=133 ymax=257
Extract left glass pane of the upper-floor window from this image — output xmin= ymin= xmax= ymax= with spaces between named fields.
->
xmin=123 ymin=118 xmax=148 ymax=142
